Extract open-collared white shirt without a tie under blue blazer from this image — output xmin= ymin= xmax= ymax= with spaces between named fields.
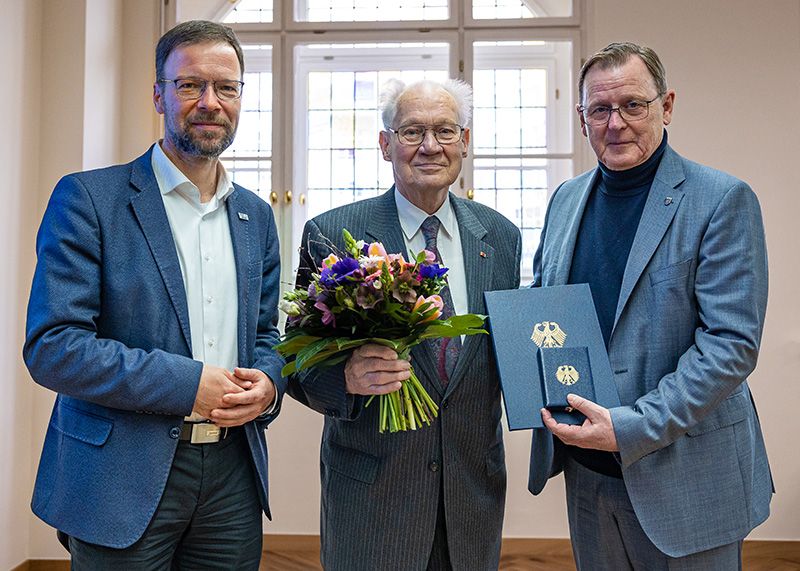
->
xmin=151 ymin=144 xmax=239 ymax=421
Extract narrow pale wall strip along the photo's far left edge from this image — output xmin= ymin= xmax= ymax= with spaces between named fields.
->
xmin=0 ymin=0 xmax=42 ymax=569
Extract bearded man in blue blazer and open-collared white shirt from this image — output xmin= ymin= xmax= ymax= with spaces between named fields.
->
xmin=24 ymin=21 xmax=285 ymax=570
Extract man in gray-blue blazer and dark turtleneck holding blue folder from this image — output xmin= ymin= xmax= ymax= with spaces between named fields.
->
xmin=529 ymin=43 xmax=773 ymax=571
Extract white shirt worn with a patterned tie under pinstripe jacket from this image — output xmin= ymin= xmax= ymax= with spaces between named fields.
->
xmin=390 ymin=189 xmax=469 ymax=318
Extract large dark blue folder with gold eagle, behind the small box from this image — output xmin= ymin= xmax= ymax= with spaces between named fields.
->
xmin=484 ymin=284 xmax=619 ymax=430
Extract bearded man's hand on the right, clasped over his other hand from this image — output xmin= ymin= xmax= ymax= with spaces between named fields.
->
xmin=209 ymin=367 xmax=275 ymax=427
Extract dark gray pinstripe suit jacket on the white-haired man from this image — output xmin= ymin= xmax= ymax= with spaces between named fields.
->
xmin=289 ymin=190 xmax=521 ymax=571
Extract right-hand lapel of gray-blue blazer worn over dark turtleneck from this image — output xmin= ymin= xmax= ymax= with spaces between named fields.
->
xmin=611 ymin=146 xmax=686 ymax=335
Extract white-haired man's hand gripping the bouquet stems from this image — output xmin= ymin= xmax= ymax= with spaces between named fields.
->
xmin=344 ymin=344 xmax=411 ymax=395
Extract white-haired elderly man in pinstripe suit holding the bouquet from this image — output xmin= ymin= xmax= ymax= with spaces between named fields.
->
xmin=290 ymin=80 xmax=521 ymax=571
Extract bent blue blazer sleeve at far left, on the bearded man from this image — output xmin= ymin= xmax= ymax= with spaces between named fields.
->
xmin=23 ymin=175 xmax=202 ymax=415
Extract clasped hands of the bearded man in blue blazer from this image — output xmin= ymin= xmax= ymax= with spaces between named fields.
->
xmin=192 ymin=365 xmax=275 ymax=427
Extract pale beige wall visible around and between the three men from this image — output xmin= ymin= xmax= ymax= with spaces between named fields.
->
xmin=12 ymin=0 xmax=800 ymax=568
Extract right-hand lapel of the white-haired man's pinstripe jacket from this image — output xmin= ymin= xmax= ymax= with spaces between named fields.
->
xmin=446 ymin=196 xmax=495 ymax=394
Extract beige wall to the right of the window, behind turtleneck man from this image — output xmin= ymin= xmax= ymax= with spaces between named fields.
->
xmin=587 ymin=0 xmax=800 ymax=540
